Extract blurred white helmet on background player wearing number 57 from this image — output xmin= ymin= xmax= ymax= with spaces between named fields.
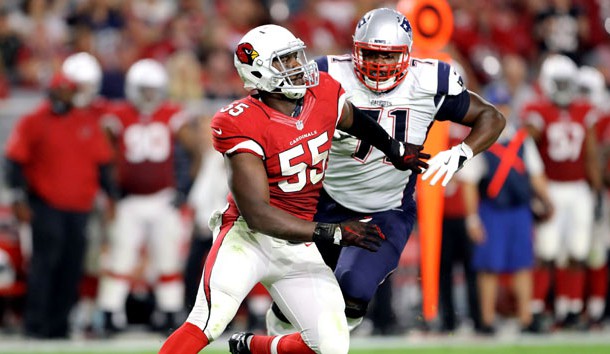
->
xmin=539 ymin=54 xmax=578 ymax=107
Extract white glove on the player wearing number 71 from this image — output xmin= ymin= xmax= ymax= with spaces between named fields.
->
xmin=422 ymin=143 xmax=474 ymax=187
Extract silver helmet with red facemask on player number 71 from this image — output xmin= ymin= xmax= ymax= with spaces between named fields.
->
xmin=352 ymin=8 xmax=413 ymax=92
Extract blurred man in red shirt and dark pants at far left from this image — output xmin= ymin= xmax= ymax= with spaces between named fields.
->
xmin=6 ymin=74 xmax=116 ymax=338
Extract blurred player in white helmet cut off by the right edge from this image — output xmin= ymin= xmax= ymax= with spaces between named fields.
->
xmin=578 ymin=66 xmax=610 ymax=328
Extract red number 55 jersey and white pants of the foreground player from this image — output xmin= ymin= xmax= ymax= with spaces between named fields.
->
xmin=187 ymin=73 xmax=349 ymax=352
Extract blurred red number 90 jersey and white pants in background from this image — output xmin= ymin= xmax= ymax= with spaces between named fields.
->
xmin=98 ymin=102 xmax=187 ymax=312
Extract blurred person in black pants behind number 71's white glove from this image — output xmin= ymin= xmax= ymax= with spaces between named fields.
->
xmin=439 ymin=124 xmax=481 ymax=332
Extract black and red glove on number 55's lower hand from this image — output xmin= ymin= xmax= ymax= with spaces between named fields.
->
xmin=312 ymin=220 xmax=385 ymax=252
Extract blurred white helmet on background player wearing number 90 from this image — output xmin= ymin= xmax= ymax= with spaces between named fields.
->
xmin=125 ymin=59 xmax=169 ymax=114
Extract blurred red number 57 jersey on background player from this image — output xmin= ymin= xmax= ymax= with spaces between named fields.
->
xmin=522 ymin=100 xmax=597 ymax=181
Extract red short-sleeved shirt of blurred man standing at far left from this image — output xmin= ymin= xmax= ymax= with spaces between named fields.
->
xmin=6 ymin=101 xmax=112 ymax=211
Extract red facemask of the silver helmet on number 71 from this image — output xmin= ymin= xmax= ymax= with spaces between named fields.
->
xmin=352 ymin=42 xmax=410 ymax=92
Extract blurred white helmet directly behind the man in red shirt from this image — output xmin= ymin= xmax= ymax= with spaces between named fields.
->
xmin=61 ymin=52 xmax=102 ymax=107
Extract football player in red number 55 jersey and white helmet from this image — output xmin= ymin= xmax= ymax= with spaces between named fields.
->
xmin=154 ymin=25 xmax=436 ymax=354
